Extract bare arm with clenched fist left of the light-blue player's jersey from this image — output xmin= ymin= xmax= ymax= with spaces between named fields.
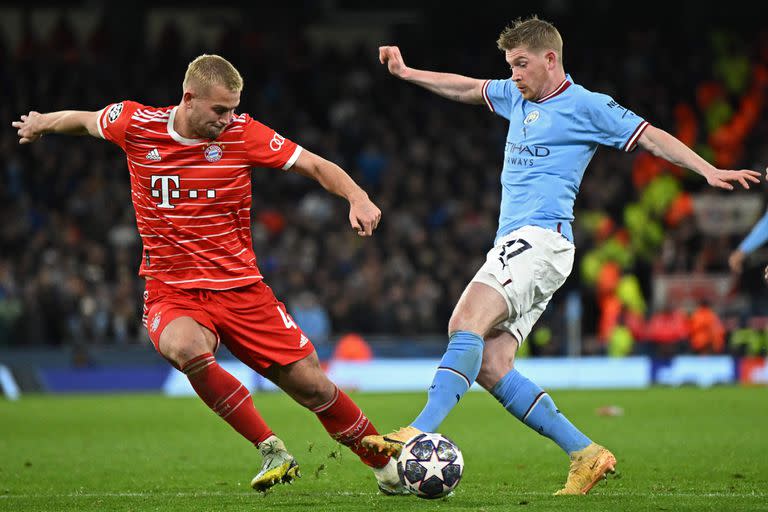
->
xmin=379 ymin=46 xmax=485 ymax=105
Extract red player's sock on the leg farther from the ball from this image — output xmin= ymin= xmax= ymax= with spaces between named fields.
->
xmin=181 ymin=352 xmax=272 ymax=445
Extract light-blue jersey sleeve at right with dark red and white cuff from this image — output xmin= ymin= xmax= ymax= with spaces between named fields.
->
xmin=581 ymin=91 xmax=648 ymax=152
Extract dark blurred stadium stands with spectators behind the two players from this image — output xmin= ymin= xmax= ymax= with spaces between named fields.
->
xmin=0 ymin=0 xmax=768 ymax=380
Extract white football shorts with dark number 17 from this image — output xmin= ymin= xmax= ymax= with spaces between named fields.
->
xmin=472 ymin=226 xmax=575 ymax=343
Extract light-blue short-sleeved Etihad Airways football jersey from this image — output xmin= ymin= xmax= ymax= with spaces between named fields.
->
xmin=483 ymin=75 xmax=648 ymax=241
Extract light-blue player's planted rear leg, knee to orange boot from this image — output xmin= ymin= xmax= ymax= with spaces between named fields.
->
xmin=477 ymin=330 xmax=616 ymax=494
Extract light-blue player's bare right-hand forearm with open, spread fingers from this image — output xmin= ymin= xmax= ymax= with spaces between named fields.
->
xmin=638 ymin=126 xmax=760 ymax=190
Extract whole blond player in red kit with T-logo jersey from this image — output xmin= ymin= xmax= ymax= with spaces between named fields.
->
xmin=12 ymin=55 xmax=406 ymax=494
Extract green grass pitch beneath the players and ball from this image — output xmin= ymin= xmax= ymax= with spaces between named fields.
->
xmin=0 ymin=387 xmax=768 ymax=512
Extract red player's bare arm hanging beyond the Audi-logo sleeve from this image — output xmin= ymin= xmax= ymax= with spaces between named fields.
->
xmin=290 ymin=148 xmax=381 ymax=236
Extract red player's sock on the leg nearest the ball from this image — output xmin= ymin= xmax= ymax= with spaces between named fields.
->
xmin=312 ymin=388 xmax=389 ymax=468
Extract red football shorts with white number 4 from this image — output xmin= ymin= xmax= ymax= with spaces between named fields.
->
xmin=144 ymin=279 xmax=315 ymax=372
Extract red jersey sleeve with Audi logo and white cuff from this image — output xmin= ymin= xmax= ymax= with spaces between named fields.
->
xmin=243 ymin=114 xmax=302 ymax=170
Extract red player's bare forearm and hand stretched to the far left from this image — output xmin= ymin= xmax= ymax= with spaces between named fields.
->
xmin=11 ymin=110 xmax=100 ymax=144
